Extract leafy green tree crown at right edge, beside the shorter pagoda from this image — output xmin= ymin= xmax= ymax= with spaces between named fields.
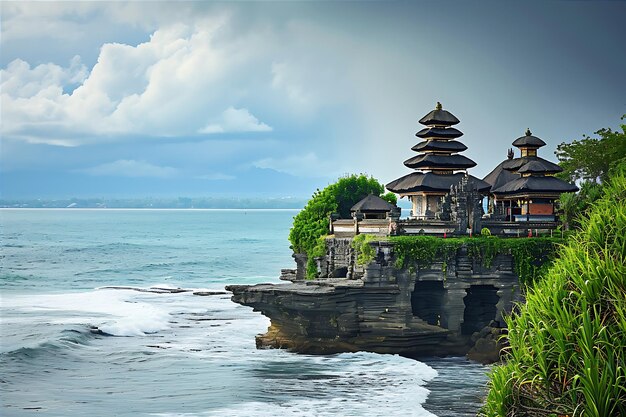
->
xmin=555 ymin=115 xmax=626 ymax=183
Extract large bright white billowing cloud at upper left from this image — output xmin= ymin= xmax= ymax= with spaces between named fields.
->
xmin=0 ymin=16 xmax=272 ymax=145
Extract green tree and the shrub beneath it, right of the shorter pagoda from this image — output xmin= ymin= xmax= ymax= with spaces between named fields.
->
xmin=556 ymin=116 xmax=626 ymax=229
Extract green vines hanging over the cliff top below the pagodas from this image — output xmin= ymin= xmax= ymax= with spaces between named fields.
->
xmin=390 ymin=236 xmax=563 ymax=285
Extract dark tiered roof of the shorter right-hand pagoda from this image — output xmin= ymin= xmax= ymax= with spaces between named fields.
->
xmin=484 ymin=129 xmax=578 ymax=198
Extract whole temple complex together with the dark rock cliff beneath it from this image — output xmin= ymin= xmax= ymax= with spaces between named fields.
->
xmin=226 ymin=103 xmax=577 ymax=363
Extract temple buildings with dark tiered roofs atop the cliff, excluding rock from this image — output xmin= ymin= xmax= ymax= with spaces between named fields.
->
xmin=330 ymin=103 xmax=578 ymax=237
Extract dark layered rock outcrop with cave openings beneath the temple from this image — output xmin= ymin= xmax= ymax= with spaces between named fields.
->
xmin=226 ymin=239 xmax=521 ymax=362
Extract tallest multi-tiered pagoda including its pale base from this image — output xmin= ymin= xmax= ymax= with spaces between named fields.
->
xmin=387 ymin=103 xmax=491 ymax=219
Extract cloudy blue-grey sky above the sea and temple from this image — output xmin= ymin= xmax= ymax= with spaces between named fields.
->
xmin=0 ymin=0 xmax=626 ymax=199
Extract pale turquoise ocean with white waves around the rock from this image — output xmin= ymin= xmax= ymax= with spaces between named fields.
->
xmin=0 ymin=209 xmax=488 ymax=417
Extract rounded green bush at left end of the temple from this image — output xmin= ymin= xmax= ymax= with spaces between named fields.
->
xmin=289 ymin=174 xmax=395 ymax=278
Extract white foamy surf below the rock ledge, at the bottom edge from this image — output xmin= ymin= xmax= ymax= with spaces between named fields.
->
xmin=152 ymin=351 xmax=437 ymax=417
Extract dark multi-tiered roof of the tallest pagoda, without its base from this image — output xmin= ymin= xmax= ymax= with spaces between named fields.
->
xmin=387 ymin=103 xmax=491 ymax=194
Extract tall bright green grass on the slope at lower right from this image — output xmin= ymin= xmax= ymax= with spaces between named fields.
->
xmin=482 ymin=167 xmax=626 ymax=417
